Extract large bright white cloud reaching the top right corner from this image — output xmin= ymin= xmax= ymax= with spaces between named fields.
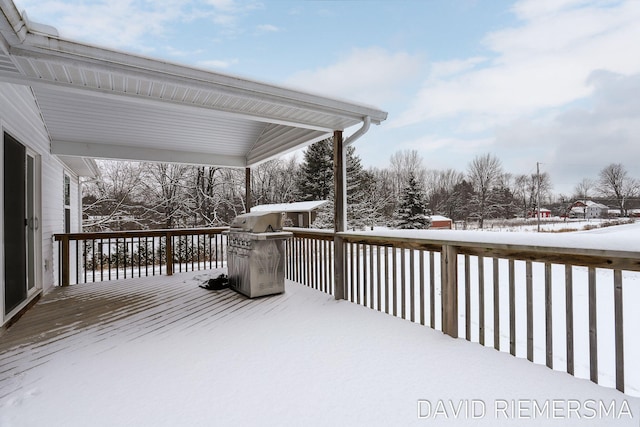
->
xmin=390 ymin=0 xmax=640 ymax=131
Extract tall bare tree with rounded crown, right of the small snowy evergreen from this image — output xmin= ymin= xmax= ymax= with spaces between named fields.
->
xmin=467 ymin=154 xmax=502 ymax=228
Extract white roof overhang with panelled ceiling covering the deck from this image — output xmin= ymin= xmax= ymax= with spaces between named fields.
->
xmin=0 ymin=0 xmax=387 ymax=172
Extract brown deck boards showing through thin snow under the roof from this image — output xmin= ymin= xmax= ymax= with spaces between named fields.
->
xmin=0 ymin=270 xmax=291 ymax=399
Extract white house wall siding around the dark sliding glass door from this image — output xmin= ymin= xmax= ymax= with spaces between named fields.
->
xmin=0 ymin=83 xmax=80 ymax=320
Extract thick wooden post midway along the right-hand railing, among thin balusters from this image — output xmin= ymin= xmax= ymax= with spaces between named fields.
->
xmin=441 ymin=245 xmax=458 ymax=338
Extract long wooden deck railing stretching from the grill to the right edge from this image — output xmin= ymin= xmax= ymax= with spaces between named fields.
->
xmin=287 ymin=229 xmax=640 ymax=395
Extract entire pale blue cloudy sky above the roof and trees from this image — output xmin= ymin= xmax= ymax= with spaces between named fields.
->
xmin=15 ymin=0 xmax=640 ymax=194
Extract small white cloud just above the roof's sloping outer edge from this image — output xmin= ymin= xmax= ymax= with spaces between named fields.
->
xmin=287 ymin=47 xmax=424 ymax=105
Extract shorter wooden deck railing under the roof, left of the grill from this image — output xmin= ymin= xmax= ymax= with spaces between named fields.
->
xmin=54 ymin=227 xmax=228 ymax=286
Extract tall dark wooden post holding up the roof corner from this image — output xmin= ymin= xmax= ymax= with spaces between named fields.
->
xmin=333 ymin=130 xmax=347 ymax=299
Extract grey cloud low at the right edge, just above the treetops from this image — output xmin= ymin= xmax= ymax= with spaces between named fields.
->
xmin=496 ymin=71 xmax=640 ymax=194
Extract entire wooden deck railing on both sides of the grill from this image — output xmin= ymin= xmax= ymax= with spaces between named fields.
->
xmin=55 ymin=228 xmax=640 ymax=395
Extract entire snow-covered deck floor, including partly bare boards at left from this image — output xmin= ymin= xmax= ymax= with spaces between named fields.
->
xmin=0 ymin=270 xmax=640 ymax=427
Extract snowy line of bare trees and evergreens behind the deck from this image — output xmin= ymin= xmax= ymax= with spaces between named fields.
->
xmin=83 ymin=139 xmax=640 ymax=231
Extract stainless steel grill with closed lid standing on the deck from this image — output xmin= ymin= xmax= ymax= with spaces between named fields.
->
xmin=227 ymin=212 xmax=293 ymax=298
